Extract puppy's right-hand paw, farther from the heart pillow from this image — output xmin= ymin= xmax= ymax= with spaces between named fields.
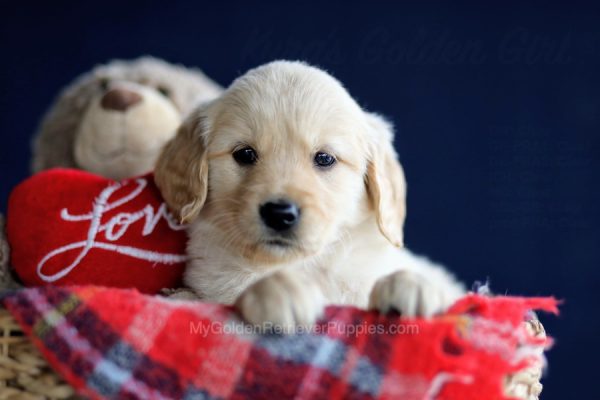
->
xmin=369 ymin=271 xmax=455 ymax=317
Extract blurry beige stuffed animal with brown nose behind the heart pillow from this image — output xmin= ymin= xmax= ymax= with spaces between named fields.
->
xmin=0 ymin=56 xmax=223 ymax=290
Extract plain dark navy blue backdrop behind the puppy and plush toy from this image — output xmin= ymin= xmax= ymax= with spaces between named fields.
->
xmin=0 ymin=1 xmax=600 ymax=399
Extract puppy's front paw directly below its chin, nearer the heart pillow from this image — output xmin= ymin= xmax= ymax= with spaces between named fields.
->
xmin=235 ymin=271 xmax=325 ymax=333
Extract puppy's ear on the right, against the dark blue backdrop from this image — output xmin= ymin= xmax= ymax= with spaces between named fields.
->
xmin=366 ymin=113 xmax=406 ymax=247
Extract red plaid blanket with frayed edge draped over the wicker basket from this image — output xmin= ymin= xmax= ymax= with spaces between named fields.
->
xmin=2 ymin=287 xmax=556 ymax=400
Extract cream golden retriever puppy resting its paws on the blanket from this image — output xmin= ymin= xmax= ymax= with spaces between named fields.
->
xmin=155 ymin=61 xmax=464 ymax=329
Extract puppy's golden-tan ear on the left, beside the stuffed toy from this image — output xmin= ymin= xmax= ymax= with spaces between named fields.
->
xmin=154 ymin=109 xmax=208 ymax=223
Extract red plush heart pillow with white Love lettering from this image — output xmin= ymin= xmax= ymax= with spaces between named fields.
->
xmin=6 ymin=169 xmax=187 ymax=293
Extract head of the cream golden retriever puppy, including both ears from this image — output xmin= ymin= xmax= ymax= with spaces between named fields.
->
xmin=156 ymin=62 xmax=404 ymax=265
